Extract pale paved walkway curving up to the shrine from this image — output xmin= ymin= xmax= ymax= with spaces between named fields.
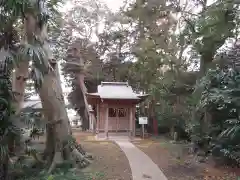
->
xmin=113 ymin=139 xmax=167 ymax=180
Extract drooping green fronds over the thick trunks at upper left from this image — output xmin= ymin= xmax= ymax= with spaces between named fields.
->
xmin=0 ymin=0 xmax=61 ymax=88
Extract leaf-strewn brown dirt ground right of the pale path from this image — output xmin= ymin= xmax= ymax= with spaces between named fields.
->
xmin=133 ymin=138 xmax=240 ymax=180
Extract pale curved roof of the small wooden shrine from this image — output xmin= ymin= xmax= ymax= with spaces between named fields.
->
xmin=87 ymin=82 xmax=148 ymax=100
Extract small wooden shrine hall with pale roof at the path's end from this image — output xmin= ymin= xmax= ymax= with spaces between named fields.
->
xmin=87 ymin=82 xmax=148 ymax=137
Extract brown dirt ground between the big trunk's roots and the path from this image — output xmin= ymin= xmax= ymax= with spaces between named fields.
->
xmin=74 ymin=132 xmax=132 ymax=180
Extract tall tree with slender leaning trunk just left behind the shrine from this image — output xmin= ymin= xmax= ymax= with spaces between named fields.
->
xmin=58 ymin=0 xmax=110 ymax=129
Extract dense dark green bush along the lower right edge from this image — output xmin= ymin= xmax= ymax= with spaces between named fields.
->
xmin=193 ymin=57 xmax=240 ymax=163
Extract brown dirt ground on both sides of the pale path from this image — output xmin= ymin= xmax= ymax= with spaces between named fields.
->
xmin=34 ymin=131 xmax=240 ymax=180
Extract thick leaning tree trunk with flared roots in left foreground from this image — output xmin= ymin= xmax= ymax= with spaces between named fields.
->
xmin=28 ymin=13 xmax=90 ymax=172
